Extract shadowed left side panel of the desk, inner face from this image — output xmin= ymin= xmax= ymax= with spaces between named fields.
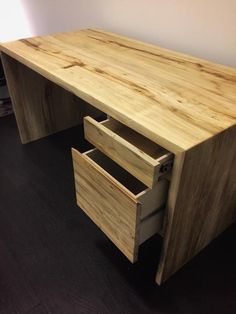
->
xmin=2 ymin=54 xmax=100 ymax=143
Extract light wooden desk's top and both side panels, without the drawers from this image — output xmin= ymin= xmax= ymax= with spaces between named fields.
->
xmin=1 ymin=29 xmax=236 ymax=284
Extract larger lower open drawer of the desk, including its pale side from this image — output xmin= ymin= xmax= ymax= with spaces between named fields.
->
xmin=72 ymin=149 xmax=169 ymax=262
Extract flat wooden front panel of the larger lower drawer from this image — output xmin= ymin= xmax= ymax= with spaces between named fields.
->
xmin=72 ymin=149 xmax=141 ymax=262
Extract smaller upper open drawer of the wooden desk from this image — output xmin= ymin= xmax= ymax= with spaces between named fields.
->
xmin=84 ymin=117 xmax=174 ymax=188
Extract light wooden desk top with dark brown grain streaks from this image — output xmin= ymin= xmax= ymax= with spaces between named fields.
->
xmin=0 ymin=29 xmax=236 ymax=153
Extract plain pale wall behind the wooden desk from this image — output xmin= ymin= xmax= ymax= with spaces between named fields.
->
xmin=0 ymin=0 xmax=236 ymax=67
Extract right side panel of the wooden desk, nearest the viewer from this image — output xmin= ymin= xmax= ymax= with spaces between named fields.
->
xmin=156 ymin=127 xmax=236 ymax=284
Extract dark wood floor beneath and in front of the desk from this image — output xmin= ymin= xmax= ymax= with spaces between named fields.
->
xmin=0 ymin=116 xmax=236 ymax=314
